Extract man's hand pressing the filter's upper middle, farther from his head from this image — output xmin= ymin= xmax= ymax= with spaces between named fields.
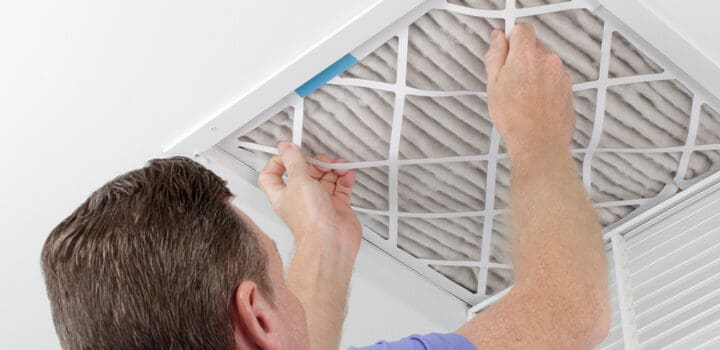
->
xmin=485 ymin=23 xmax=574 ymax=158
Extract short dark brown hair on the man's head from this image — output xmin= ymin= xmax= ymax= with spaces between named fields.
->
xmin=41 ymin=157 xmax=272 ymax=349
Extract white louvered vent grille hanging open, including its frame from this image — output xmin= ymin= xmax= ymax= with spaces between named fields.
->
xmin=599 ymin=177 xmax=720 ymax=349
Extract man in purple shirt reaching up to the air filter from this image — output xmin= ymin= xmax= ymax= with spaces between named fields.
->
xmin=42 ymin=24 xmax=610 ymax=350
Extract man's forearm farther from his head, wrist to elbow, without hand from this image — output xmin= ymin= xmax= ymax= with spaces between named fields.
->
xmin=511 ymin=147 xmax=608 ymax=334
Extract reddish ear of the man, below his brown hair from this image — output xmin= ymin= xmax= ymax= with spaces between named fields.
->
xmin=233 ymin=281 xmax=281 ymax=350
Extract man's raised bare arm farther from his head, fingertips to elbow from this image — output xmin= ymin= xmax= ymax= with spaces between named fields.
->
xmin=458 ymin=24 xmax=610 ymax=349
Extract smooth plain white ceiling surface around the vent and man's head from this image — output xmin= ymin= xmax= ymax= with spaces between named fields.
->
xmin=0 ymin=0 xmax=720 ymax=349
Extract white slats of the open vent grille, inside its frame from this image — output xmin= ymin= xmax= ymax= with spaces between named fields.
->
xmin=627 ymin=212 xmax=720 ymax=349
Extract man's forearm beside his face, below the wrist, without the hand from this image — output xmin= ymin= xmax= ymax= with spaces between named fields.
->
xmin=287 ymin=231 xmax=357 ymax=350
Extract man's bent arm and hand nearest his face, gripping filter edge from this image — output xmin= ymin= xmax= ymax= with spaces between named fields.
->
xmin=258 ymin=142 xmax=361 ymax=350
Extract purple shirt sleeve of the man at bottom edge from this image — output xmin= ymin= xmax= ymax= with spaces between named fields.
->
xmin=349 ymin=333 xmax=477 ymax=350
